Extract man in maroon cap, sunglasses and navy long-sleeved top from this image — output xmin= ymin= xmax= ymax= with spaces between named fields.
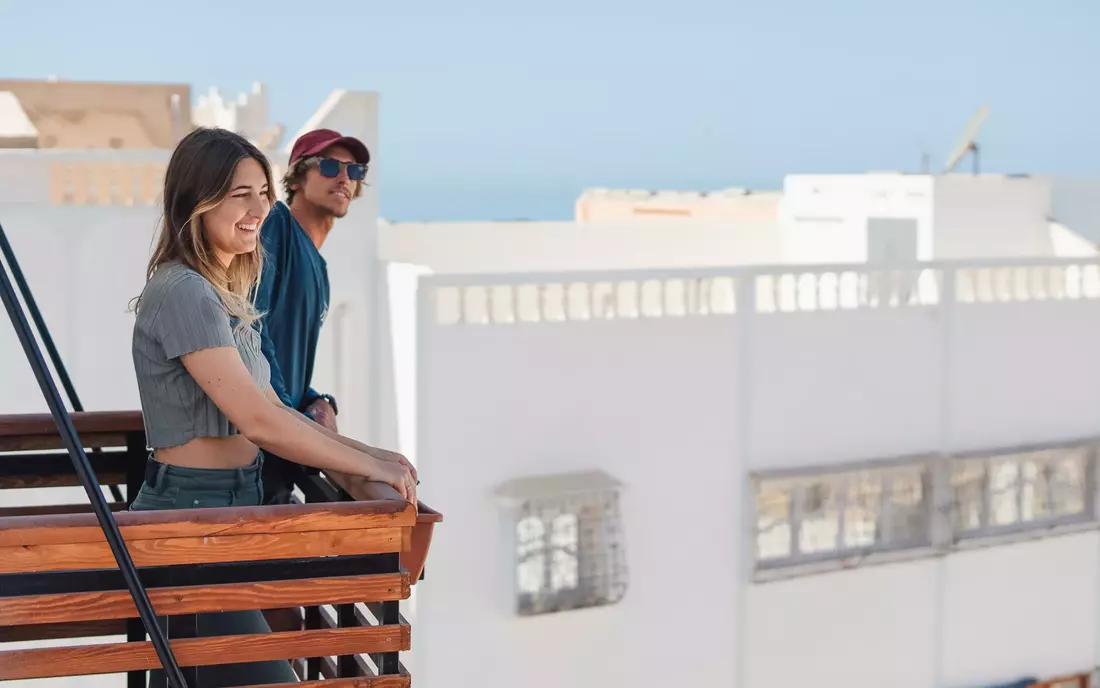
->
xmin=256 ymin=129 xmax=406 ymax=504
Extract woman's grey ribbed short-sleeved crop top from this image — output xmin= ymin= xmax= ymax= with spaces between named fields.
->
xmin=133 ymin=262 xmax=271 ymax=449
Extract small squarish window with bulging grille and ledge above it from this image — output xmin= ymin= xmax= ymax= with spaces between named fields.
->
xmin=497 ymin=471 xmax=627 ymax=615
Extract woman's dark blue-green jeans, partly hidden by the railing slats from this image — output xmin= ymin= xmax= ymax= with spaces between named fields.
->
xmin=130 ymin=455 xmax=298 ymax=688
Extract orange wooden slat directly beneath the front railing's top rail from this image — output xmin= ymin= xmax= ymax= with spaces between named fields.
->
xmin=0 ymin=527 xmax=407 ymax=574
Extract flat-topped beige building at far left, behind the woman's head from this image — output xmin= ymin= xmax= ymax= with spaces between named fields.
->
xmin=0 ymin=79 xmax=191 ymax=149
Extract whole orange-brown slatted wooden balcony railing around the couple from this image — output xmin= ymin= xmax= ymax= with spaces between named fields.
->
xmin=0 ymin=412 xmax=441 ymax=688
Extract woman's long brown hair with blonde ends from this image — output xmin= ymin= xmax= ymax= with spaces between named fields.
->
xmin=133 ymin=128 xmax=275 ymax=327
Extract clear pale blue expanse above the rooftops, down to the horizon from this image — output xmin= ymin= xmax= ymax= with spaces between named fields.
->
xmin=0 ymin=0 xmax=1100 ymax=220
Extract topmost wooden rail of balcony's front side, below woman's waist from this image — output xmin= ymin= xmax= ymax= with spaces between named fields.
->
xmin=0 ymin=500 xmax=416 ymax=547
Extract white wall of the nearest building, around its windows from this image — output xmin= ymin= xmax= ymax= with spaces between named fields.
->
xmin=409 ymin=257 xmax=1100 ymax=688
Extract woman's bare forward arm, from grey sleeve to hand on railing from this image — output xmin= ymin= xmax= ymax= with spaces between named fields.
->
xmin=179 ymin=347 xmax=416 ymax=504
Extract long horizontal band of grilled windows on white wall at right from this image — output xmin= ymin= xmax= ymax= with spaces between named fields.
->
xmin=752 ymin=441 xmax=1098 ymax=577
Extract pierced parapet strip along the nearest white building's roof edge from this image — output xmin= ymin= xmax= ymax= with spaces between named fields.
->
xmin=421 ymin=259 xmax=1100 ymax=325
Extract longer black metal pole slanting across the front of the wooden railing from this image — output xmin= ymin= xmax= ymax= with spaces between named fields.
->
xmin=0 ymin=226 xmax=187 ymax=688
